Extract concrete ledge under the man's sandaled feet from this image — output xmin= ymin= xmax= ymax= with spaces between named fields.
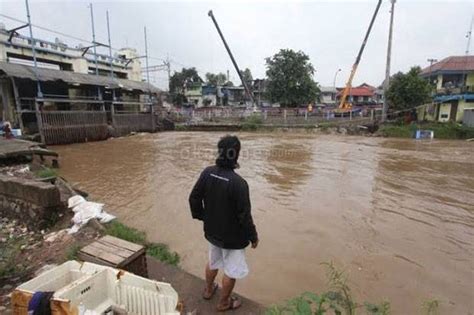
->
xmin=147 ymin=256 xmax=265 ymax=315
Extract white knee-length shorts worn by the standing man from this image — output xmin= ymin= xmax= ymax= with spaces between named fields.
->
xmin=209 ymin=243 xmax=249 ymax=279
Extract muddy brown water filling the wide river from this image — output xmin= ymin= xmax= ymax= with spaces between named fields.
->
xmin=55 ymin=133 xmax=474 ymax=314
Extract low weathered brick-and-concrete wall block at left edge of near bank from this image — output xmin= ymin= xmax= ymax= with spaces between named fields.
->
xmin=0 ymin=175 xmax=65 ymax=230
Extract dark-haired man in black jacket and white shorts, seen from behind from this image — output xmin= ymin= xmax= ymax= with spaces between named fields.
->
xmin=189 ymin=136 xmax=258 ymax=312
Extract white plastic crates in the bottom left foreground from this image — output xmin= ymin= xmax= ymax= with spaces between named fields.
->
xmin=12 ymin=261 xmax=179 ymax=315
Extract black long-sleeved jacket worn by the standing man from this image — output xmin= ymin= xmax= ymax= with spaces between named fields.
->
xmin=189 ymin=166 xmax=258 ymax=249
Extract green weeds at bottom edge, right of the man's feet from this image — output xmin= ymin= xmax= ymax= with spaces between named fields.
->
xmin=265 ymin=262 xmax=439 ymax=315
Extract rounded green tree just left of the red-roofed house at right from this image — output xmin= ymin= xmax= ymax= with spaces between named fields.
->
xmin=385 ymin=66 xmax=431 ymax=110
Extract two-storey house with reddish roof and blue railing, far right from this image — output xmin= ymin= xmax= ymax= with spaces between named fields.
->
xmin=418 ymin=55 xmax=474 ymax=122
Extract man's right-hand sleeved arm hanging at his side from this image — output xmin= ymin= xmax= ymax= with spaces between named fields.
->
xmin=237 ymin=181 xmax=258 ymax=247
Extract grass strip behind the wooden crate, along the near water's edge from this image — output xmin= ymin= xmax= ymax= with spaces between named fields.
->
xmin=105 ymin=220 xmax=180 ymax=266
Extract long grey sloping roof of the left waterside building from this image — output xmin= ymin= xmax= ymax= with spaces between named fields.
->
xmin=0 ymin=61 xmax=160 ymax=93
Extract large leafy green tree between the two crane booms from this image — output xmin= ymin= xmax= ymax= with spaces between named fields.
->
xmin=265 ymin=49 xmax=320 ymax=107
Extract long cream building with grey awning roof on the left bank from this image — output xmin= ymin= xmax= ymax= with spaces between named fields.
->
xmin=0 ymin=24 xmax=160 ymax=133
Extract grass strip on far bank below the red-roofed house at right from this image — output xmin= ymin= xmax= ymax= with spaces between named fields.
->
xmin=379 ymin=122 xmax=474 ymax=139
